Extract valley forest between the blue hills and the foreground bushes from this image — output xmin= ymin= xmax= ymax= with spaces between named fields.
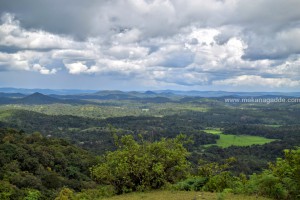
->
xmin=0 ymin=96 xmax=300 ymax=175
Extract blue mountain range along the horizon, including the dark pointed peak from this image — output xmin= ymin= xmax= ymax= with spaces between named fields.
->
xmin=0 ymin=88 xmax=300 ymax=104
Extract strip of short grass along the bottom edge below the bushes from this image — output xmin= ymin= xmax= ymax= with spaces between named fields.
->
xmin=101 ymin=191 xmax=267 ymax=200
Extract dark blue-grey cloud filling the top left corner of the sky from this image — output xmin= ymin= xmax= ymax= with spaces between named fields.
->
xmin=0 ymin=0 xmax=107 ymax=39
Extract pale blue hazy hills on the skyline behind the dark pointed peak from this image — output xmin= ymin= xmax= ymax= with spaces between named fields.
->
xmin=0 ymin=88 xmax=300 ymax=99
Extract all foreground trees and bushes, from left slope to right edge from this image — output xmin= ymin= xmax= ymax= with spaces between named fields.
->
xmin=0 ymin=130 xmax=300 ymax=200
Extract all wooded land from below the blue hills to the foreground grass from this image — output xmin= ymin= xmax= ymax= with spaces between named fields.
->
xmin=0 ymin=91 xmax=300 ymax=199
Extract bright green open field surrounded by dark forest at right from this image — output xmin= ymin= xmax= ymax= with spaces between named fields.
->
xmin=205 ymin=129 xmax=275 ymax=148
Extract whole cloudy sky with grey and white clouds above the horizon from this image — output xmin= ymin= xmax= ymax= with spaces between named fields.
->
xmin=0 ymin=0 xmax=300 ymax=92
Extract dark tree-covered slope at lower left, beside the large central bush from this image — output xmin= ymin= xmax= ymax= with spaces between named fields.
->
xmin=0 ymin=129 xmax=96 ymax=200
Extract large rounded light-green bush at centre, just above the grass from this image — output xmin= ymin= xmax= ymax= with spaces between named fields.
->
xmin=91 ymin=135 xmax=189 ymax=193
